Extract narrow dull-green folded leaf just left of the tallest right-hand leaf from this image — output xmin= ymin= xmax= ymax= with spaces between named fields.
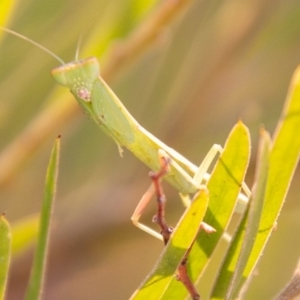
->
xmin=210 ymin=130 xmax=271 ymax=299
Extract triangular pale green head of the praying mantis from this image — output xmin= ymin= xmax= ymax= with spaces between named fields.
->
xmin=52 ymin=57 xmax=100 ymax=102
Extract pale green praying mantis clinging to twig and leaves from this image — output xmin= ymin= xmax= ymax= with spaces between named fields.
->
xmin=0 ymin=27 xmax=251 ymax=298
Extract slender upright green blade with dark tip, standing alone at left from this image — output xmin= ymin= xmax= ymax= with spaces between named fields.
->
xmin=25 ymin=138 xmax=60 ymax=300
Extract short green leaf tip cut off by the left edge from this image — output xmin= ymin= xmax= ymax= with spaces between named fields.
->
xmin=0 ymin=215 xmax=11 ymax=300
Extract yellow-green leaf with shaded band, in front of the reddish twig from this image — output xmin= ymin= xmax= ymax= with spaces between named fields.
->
xmin=131 ymin=189 xmax=208 ymax=300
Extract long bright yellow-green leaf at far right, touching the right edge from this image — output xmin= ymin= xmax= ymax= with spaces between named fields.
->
xmin=239 ymin=62 xmax=300 ymax=286
